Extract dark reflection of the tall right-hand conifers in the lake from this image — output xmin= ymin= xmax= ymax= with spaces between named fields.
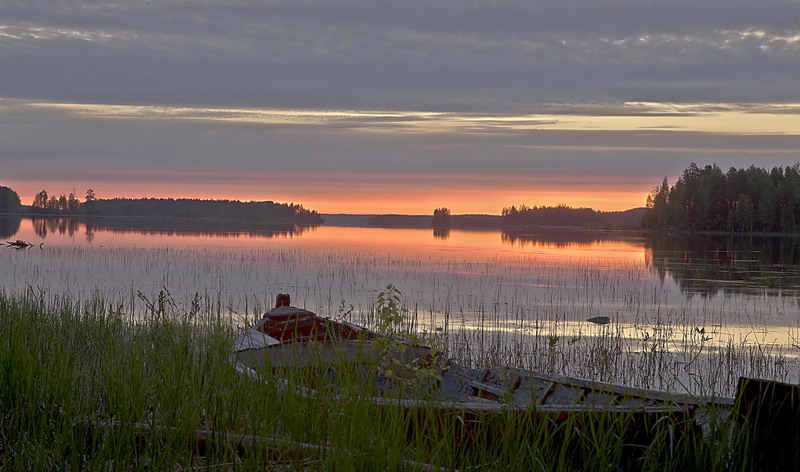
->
xmin=645 ymin=235 xmax=800 ymax=296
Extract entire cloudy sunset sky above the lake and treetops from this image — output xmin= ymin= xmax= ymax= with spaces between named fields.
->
xmin=0 ymin=0 xmax=800 ymax=214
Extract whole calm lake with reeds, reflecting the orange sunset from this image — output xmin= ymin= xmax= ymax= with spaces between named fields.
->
xmin=0 ymin=217 xmax=800 ymax=393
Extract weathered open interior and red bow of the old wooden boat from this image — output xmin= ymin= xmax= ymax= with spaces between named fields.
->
xmin=232 ymin=295 xmax=733 ymax=414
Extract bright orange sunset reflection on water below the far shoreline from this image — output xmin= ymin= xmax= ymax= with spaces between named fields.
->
xmin=7 ymin=218 xmax=644 ymax=263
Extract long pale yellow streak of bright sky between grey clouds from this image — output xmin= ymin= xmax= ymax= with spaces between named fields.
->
xmin=16 ymin=101 xmax=800 ymax=136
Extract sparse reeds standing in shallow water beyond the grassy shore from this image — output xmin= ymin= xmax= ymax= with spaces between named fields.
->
xmin=0 ymin=236 xmax=800 ymax=396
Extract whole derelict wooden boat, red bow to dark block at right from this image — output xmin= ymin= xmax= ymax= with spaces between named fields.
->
xmin=231 ymin=295 xmax=800 ymax=470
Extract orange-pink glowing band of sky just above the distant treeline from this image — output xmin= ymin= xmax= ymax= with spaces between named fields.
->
xmin=9 ymin=173 xmax=655 ymax=214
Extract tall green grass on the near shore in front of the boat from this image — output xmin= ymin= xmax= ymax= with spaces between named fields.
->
xmin=0 ymin=292 xmax=780 ymax=471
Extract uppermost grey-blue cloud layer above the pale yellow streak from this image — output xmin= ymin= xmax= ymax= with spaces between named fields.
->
xmin=0 ymin=0 xmax=800 ymax=112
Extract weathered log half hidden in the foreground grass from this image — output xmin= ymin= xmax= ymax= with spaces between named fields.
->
xmin=86 ymin=421 xmax=457 ymax=472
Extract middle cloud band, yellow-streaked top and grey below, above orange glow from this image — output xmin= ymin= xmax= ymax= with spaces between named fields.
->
xmin=0 ymin=99 xmax=800 ymax=183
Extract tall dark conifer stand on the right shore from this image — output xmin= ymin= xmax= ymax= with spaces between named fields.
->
xmin=642 ymin=163 xmax=800 ymax=233
